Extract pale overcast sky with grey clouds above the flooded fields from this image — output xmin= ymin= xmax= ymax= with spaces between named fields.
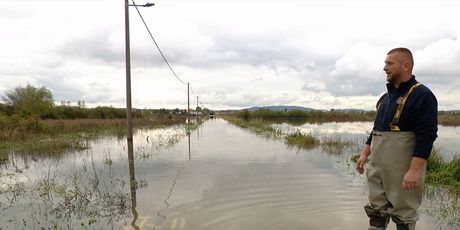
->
xmin=0 ymin=0 xmax=460 ymax=110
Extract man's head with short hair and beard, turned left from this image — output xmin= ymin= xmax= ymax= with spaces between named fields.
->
xmin=383 ymin=48 xmax=414 ymax=86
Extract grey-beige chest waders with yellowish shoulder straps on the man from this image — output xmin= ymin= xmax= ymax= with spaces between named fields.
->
xmin=364 ymin=83 xmax=425 ymax=229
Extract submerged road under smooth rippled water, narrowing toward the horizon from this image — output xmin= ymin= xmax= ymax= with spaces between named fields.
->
xmin=130 ymin=119 xmax=445 ymax=230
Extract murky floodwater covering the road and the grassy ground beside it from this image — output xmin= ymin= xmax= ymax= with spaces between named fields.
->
xmin=0 ymin=119 xmax=455 ymax=230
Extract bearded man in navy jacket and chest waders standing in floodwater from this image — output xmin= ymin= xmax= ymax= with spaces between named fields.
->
xmin=356 ymin=48 xmax=438 ymax=230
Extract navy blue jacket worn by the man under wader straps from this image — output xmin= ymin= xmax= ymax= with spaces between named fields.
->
xmin=366 ymin=76 xmax=438 ymax=159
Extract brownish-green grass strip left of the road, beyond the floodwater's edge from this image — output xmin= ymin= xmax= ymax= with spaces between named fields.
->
xmin=0 ymin=116 xmax=185 ymax=162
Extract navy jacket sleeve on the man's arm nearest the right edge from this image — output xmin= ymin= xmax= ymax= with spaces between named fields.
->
xmin=413 ymin=91 xmax=438 ymax=159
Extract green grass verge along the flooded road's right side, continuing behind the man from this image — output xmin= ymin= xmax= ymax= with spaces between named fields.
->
xmin=224 ymin=115 xmax=460 ymax=226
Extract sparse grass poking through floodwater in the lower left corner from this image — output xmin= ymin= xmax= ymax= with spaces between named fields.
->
xmin=0 ymin=157 xmax=134 ymax=229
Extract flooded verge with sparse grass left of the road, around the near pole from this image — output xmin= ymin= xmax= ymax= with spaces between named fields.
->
xmin=0 ymin=126 xmax=184 ymax=229
